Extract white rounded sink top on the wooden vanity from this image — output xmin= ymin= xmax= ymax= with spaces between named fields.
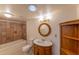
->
xmin=33 ymin=39 xmax=52 ymax=46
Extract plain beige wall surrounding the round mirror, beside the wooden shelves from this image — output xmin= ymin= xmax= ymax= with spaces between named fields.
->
xmin=27 ymin=6 xmax=76 ymax=54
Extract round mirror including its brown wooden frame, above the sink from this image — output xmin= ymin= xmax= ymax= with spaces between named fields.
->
xmin=38 ymin=23 xmax=51 ymax=37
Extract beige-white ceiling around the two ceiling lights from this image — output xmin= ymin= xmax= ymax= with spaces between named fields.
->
xmin=0 ymin=4 xmax=76 ymax=21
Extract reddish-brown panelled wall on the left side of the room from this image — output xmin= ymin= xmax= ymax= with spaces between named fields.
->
xmin=0 ymin=21 xmax=26 ymax=44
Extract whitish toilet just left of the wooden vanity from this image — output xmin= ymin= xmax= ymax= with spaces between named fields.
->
xmin=22 ymin=39 xmax=33 ymax=55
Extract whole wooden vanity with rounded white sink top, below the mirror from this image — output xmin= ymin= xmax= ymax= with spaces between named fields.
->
xmin=32 ymin=39 xmax=52 ymax=55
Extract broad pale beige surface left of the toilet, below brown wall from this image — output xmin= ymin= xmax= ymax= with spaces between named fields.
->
xmin=0 ymin=39 xmax=26 ymax=55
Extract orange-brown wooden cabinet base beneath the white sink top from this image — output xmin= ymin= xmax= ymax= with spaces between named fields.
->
xmin=32 ymin=44 xmax=52 ymax=55
